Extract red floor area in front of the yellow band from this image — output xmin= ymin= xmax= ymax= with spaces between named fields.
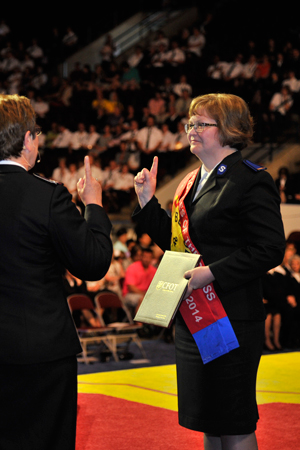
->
xmin=76 ymin=394 xmax=300 ymax=450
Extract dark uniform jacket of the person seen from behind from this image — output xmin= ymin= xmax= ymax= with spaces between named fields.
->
xmin=0 ymin=165 xmax=112 ymax=364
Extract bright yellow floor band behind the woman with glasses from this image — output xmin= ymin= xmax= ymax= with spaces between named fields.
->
xmin=78 ymin=352 xmax=300 ymax=411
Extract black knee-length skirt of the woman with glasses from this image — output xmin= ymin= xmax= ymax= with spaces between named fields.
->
xmin=175 ymin=313 xmax=264 ymax=436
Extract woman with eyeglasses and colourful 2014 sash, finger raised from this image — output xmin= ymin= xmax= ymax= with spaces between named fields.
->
xmin=133 ymin=94 xmax=285 ymax=450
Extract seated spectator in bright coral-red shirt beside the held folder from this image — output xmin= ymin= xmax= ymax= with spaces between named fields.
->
xmin=123 ymin=248 xmax=156 ymax=317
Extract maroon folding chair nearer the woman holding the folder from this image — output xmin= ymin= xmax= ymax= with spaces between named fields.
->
xmin=95 ymin=292 xmax=146 ymax=361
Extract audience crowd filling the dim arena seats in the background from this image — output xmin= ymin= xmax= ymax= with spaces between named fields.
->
xmin=0 ymin=11 xmax=300 ymax=351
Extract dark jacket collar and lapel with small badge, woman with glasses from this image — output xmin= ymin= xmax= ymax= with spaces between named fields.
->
xmin=191 ymin=151 xmax=242 ymax=204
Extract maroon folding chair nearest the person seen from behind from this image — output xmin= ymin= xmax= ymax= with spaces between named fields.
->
xmin=67 ymin=294 xmax=112 ymax=364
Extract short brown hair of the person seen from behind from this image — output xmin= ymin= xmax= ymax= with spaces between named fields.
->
xmin=0 ymin=95 xmax=36 ymax=160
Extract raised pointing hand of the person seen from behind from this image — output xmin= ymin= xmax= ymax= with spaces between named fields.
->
xmin=77 ymin=156 xmax=102 ymax=206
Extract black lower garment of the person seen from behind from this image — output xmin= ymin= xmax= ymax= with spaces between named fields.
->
xmin=0 ymin=356 xmax=77 ymax=450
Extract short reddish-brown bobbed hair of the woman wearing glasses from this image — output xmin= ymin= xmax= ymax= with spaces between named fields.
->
xmin=189 ymin=94 xmax=253 ymax=150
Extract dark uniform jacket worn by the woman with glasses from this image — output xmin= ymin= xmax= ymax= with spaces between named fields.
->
xmin=133 ymin=152 xmax=285 ymax=320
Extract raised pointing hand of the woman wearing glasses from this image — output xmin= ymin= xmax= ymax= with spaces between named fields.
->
xmin=134 ymin=156 xmax=158 ymax=208
